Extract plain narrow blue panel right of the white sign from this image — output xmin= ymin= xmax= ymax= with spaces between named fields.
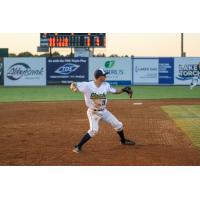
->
xmin=159 ymin=58 xmax=174 ymax=84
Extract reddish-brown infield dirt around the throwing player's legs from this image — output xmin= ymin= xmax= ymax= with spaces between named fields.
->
xmin=0 ymin=100 xmax=200 ymax=166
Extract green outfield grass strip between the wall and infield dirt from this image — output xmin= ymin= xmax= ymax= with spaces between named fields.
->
xmin=0 ymin=86 xmax=200 ymax=102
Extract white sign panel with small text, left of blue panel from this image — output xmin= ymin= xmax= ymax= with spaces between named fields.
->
xmin=133 ymin=58 xmax=159 ymax=84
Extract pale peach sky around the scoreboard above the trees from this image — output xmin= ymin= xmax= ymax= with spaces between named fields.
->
xmin=0 ymin=33 xmax=200 ymax=56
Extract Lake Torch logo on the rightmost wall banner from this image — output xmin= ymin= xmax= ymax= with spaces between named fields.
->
xmin=176 ymin=64 xmax=200 ymax=81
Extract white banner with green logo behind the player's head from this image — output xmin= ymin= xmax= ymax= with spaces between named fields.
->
xmin=89 ymin=57 xmax=132 ymax=85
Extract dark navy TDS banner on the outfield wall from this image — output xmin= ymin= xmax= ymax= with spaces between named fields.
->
xmin=46 ymin=58 xmax=88 ymax=85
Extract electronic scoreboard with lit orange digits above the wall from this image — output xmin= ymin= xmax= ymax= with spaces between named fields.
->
xmin=40 ymin=33 xmax=106 ymax=48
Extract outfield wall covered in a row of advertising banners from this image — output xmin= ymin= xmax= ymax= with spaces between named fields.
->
xmin=0 ymin=57 xmax=200 ymax=86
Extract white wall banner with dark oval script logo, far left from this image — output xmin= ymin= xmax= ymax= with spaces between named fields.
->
xmin=4 ymin=57 xmax=46 ymax=86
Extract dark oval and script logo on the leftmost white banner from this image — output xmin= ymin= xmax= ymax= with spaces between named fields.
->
xmin=7 ymin=63 xmax=44 ymax=80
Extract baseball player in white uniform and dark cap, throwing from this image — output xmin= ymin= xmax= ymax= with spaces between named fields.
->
xmin=70 ymin=69 xmax=135 ymax=153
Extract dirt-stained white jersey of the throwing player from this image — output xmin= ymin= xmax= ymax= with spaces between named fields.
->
xmin=77 ymin=81 xmax=117 ymax=110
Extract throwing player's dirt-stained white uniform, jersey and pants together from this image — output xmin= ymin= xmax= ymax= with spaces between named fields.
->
xmin=77 ymin=81 xmax=123 ymax=137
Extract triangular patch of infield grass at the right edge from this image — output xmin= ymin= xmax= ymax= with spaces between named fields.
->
xmin=162 ymin=105 xmax=200 ymax=149
